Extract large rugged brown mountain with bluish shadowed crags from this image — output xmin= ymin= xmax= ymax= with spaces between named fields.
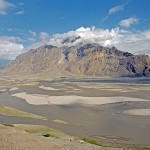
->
xmin=2 ymin=42 xmax=150 ymax=78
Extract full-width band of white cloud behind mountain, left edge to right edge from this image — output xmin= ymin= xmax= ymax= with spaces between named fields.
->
xmin=0 ymin=27 xmax=150 ymax=59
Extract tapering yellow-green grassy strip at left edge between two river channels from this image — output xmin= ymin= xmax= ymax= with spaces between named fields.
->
xmin=0 ymin=104 xmax=46 ymax=120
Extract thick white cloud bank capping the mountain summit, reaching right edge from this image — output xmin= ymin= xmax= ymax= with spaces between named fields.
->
xmin=48 ymin=27 xmax=150 ymax=55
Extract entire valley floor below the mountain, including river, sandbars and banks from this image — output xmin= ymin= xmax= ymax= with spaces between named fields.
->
xmin=0 ymin=79 xmax=150 ymax=150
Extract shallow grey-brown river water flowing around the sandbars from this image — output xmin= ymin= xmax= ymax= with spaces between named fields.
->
xmin=0 ymin=81 xmax=150 ymax=145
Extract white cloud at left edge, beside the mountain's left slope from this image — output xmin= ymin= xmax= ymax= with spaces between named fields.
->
xmin=0 ymin=36 xmax=24 ymax=60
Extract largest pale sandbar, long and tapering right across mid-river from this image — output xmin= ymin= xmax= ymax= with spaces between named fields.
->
xmin=12 ymin=92 xmax=149 ymax=105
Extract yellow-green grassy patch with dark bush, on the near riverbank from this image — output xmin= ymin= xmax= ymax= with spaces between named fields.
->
xmin=14 ymin=124 xmax=65 ymax=138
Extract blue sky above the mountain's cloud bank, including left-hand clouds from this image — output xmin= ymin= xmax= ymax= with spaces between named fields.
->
xmin=0 ymin=0 xmax=150 ymax=58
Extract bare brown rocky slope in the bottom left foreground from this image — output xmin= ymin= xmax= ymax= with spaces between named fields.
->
xmin=0 ymin=125 xmax=121 ymax=150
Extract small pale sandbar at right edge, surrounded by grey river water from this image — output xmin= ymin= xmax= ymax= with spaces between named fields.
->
xmin=124 ymin=109 xmax=150 ymax=116
